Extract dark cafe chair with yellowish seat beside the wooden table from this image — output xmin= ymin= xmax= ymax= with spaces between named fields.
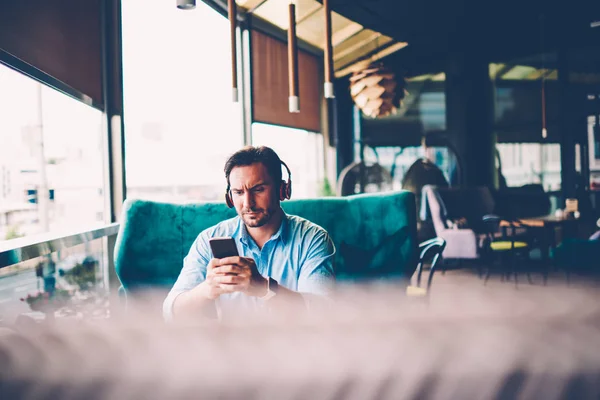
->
xmin=480 ymin=214 xmax=533 ymax=287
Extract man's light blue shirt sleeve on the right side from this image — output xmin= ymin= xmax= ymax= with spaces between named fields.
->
xmin=298 ymin=230 xmax=335 ymax=296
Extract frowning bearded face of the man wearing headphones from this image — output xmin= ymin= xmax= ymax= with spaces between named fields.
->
xmin=229 ymin=163 xmax=279 ymax=228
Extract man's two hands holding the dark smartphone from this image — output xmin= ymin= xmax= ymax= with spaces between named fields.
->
xmin=211 ymin=256 xmax=267 ymax=298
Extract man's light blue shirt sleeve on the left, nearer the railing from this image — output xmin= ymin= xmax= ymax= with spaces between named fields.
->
xmin=163 ymin=231 xmax=212 ymax=321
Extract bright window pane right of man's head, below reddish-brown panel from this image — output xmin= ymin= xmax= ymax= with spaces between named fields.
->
xmin=252 ymin=123 xmax=324 ymax=199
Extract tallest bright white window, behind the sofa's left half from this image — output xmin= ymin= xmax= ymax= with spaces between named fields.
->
xmin=122 ymin=0 xmax=243 ymax=202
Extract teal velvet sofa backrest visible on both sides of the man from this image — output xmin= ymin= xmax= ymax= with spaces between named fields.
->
xmin=115 ymin=191 xmax=418 ymax=291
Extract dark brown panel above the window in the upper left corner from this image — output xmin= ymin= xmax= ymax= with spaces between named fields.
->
xmin=0 ymin=0 xmax=103 ymax=104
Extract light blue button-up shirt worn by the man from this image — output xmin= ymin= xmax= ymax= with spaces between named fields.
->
xmin=163 ymin=213 xmax=335 ymax=320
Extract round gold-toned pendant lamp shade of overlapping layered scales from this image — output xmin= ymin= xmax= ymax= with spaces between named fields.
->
xmin=350 ymin=63 xmax=406 ymax=118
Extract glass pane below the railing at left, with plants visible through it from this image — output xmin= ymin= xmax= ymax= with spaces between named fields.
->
xmin=0 ymin=239 xmax=108 ymax=324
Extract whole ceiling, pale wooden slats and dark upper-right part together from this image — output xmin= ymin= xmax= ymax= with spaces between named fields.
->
xmin=237 ymin=0 xmax=600 ymax=76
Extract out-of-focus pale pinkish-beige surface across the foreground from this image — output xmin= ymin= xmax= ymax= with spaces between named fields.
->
xmin=0 ymin=271 xmax=600 ymax=399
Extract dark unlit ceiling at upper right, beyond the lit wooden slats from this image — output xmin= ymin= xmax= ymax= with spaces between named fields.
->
xmin=332 ymin=0 xmax=600 ymax=75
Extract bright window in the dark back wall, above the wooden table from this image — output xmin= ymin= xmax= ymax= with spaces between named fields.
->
xmin=496 ymin=143 xmax=561 ymax=191
